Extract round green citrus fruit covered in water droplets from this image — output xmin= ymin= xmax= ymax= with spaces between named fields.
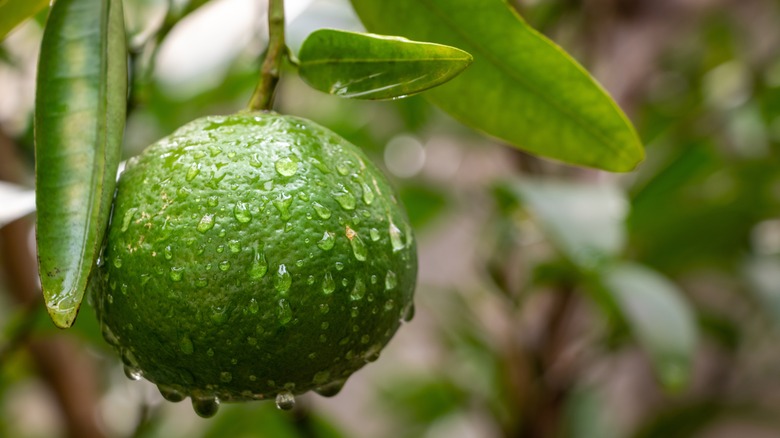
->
xmin=93 ymin=112 xmax=417 ymax=401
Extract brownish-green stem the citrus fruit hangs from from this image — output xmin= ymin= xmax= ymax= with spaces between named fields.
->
xmin=249 ymin=0 xmax=287 ymax=111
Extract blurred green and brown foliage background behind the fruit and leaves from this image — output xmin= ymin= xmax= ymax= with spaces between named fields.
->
xmin=0 ymin=0 xmax=780 ymax=438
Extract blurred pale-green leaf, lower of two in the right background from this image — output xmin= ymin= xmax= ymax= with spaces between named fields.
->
xmin=603 ymin=263 xmax=698 ymax=390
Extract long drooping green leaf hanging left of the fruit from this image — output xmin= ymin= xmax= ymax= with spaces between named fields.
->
xmin=35 ymin=0 xmax=127 ymax=328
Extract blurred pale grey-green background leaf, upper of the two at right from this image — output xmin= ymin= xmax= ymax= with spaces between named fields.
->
xmin=508 ymin=178 xmax=628 ymax=270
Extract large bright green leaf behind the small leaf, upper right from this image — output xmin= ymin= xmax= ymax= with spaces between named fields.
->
xmin=352 ymin=0 xmax=644 ymax=172
